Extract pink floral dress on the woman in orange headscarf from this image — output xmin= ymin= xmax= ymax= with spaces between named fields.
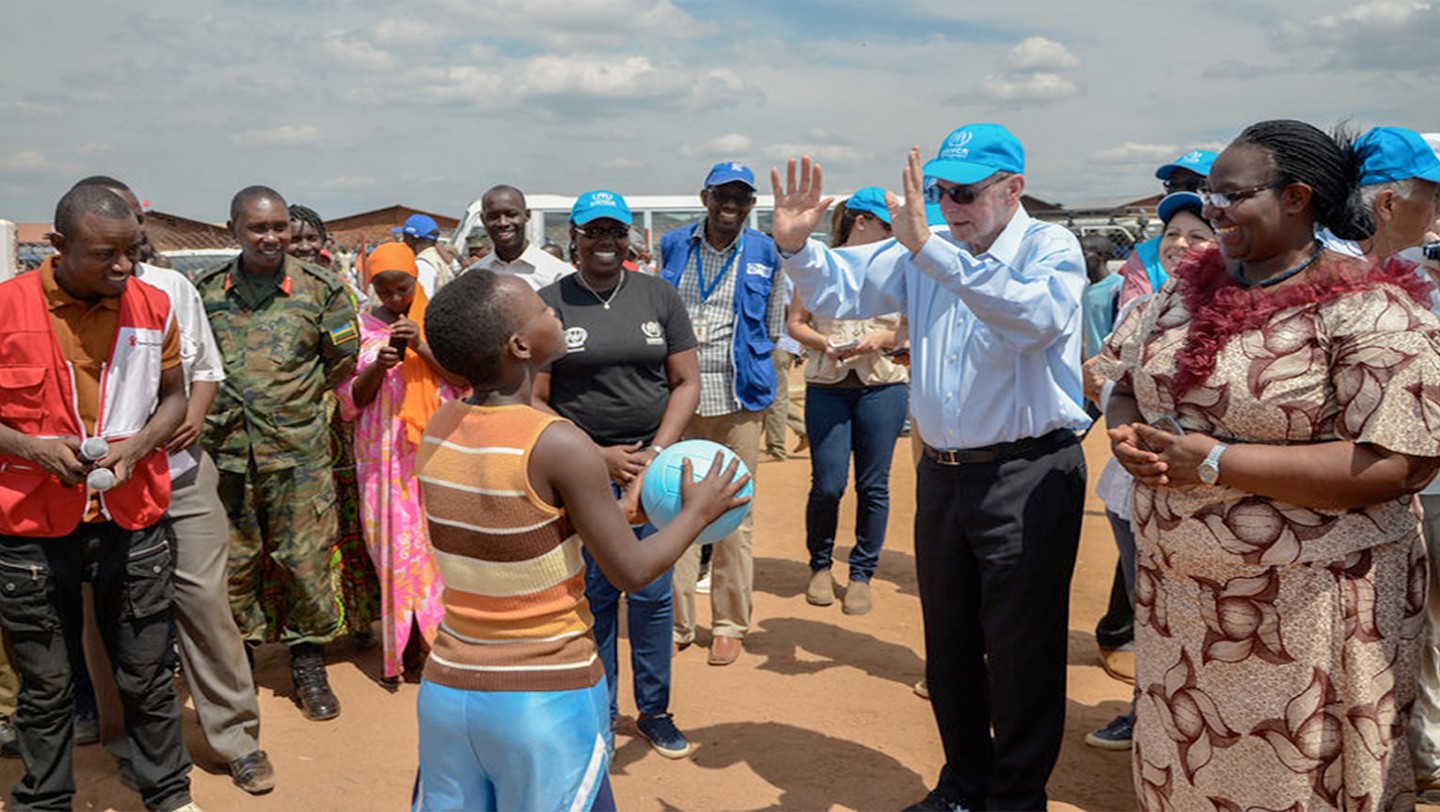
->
xmin=336 ymin=312 xmax=452 ymax=677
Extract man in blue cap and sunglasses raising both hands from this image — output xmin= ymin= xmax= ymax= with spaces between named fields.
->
xmin=772 ymin=124 xmax=1090 ymax=811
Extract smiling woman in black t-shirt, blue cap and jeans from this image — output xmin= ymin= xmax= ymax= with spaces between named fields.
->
xmin=534 ymin=190 xmax=700 ymax=759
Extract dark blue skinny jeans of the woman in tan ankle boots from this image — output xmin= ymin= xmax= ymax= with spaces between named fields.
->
xmin=805 ymin=383 xmax=910 ymax=582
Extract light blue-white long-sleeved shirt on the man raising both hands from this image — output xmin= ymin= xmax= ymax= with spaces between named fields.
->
xmin=782 ymin=207 xmax=1090 ymax=449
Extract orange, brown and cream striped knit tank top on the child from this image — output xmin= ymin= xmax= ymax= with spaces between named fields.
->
xmin=416 ymin=400 xmax=605 ymax=691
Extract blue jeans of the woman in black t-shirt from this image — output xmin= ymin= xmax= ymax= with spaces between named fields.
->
xmin=585 ymin=512 xmax=675 ymax=717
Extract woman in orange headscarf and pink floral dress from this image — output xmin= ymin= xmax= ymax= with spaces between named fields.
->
xmin=337 ymin=242 xmax=465 ymax=684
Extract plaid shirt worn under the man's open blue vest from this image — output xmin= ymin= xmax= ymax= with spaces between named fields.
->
xmin=680 ymin=222 xmax=785 ymax=418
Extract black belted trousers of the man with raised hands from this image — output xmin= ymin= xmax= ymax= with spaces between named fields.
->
xmin=914 ymin=435 xmax=1086 ymax=809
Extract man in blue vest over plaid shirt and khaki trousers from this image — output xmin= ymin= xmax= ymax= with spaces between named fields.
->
xmin=660 ymin=161 xmax=785 ymax=665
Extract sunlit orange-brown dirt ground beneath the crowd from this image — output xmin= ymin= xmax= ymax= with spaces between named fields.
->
xmin=0 ymin=417 xmax=1157 ymax=812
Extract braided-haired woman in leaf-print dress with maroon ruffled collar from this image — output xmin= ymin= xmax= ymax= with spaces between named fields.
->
xmin=1097 ymin=121 xmax=1440 ymax=811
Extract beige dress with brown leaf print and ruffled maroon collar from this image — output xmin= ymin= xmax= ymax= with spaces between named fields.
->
xmin=1100 ymin=252 xmax=1440 ymax=812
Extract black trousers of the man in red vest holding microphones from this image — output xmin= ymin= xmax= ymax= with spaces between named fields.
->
xmin=0 ymin=521 xmax=190 ymax=809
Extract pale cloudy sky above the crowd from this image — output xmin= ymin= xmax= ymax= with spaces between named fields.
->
xmin=0 ymin=0 xmax=1440 ymax=222
